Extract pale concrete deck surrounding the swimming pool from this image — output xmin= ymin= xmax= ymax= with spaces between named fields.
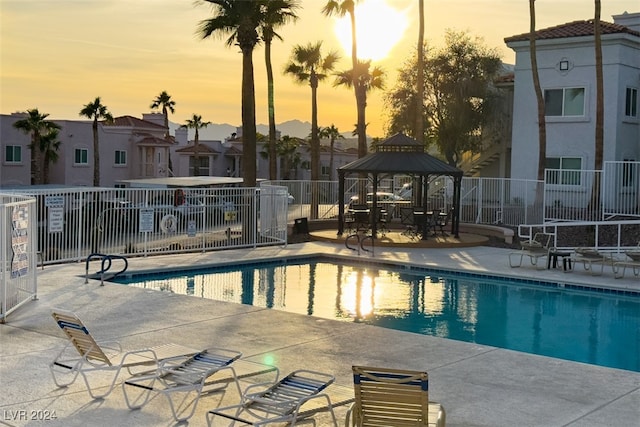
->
xmin=0 ymin=242 xmax=640 ymax=427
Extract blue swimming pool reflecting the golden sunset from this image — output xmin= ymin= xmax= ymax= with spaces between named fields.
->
xmin=114 ymin=258 xmax=640 ymax=372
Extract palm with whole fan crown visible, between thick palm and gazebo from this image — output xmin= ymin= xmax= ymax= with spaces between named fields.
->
xmin=284 ymin=42 xmax=339 ymax=219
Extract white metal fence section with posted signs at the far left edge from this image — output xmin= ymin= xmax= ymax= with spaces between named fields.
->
xmin=0 ymin=194 xmax=37 ymax=323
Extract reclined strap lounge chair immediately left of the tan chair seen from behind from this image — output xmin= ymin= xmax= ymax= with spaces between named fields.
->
xmin=207 ymin=369 xmax=338 ymax=427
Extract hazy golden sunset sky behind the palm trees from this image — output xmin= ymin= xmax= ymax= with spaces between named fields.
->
xmin=0 ymin=0 xmax=640 ymax=136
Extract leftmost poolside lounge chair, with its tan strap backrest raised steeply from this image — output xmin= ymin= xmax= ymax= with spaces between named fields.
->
xmin=49 ymin=309 xmax=198 ymax=399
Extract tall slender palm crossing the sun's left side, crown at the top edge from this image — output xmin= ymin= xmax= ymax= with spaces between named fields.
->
xmin=322 ymin=0 xmax=367 ymax=158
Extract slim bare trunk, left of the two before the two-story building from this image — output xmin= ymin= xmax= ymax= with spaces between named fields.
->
xmin=529 ymin=0 xmax=547 ymax=182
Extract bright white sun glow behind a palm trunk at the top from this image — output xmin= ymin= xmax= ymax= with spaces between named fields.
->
xmin=335 ymin=0 xmax=409 ymax=61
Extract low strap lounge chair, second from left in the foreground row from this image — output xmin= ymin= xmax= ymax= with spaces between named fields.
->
xmin=122 ymin=348 xmax=242 ymax=422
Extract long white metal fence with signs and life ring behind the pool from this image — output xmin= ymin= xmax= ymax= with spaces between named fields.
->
xmin=2 ymin=186 xmax=288 ymax=264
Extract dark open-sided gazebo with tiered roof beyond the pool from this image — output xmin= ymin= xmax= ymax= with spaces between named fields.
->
xmin=338 ymin=133 xmax=463 ymax=238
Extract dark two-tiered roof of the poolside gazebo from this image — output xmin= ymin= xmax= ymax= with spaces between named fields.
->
xmin=338 ymin=133 xmax=463 ymax=177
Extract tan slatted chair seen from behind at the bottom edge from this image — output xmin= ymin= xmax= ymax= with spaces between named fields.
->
xmin=345 ymin=366 xmax=446 ymax=427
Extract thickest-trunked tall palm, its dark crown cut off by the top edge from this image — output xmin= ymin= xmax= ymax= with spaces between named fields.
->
xmin=197 ymin=0 xmax=267 ymax=187
